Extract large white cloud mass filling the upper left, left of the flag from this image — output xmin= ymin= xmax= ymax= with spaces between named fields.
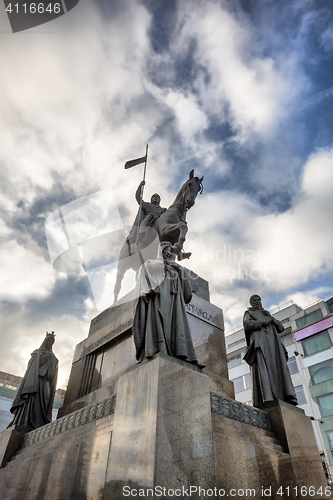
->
xmin=0 ymin=2 xmax=154 ymax=206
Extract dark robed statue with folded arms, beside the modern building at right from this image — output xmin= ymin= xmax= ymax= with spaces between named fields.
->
xmin=243 ymin=295 xmax=297 ymax=406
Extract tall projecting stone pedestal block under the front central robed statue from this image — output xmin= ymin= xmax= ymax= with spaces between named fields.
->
xmin=105 ymin=355 xmax=215 ymax=499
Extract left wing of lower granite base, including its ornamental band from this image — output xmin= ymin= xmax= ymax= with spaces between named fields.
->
xmin=0 ymin=398 xmax=114 ymax=500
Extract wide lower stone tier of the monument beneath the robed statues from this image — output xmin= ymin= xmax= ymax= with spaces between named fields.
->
xmin=0 ymin=355 xmax=327 ymax=500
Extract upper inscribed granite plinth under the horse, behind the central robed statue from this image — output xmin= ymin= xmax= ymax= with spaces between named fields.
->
xmin=59 ymin=276 xmax=234 ymax=416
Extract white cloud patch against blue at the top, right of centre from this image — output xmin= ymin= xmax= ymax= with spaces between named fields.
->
xmin=163 ymin=2 xmax=295 ymax=140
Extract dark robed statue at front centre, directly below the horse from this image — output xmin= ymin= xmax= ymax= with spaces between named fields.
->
xmin=133 ymin=241 xmax=205 ymax=368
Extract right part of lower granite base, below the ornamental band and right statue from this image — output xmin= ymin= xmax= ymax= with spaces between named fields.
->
xmin=213 ymin=402 xmax=327 ymax=500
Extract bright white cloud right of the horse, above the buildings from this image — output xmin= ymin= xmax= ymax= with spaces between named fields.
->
xmin=186 ymin=147 xmax=333 ymax=326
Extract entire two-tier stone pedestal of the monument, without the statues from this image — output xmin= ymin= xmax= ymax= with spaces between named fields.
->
xmin=0 ymin=280 xmax=328 ymax=500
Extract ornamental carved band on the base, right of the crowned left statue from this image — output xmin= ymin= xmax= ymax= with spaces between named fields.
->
xmin=22 ymin=395 xmax=116 ymax=448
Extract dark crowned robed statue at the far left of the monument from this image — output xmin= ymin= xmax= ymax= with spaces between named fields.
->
xmin=8 ymin=332 xmax=58 ymax=430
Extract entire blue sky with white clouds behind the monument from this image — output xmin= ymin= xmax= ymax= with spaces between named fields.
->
xmin=0 ymin=0 xmax=333 ymax=386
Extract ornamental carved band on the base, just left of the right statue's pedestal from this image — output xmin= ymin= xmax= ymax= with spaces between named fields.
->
xmin=210 ymin=393 xmax=272 ymax=431
